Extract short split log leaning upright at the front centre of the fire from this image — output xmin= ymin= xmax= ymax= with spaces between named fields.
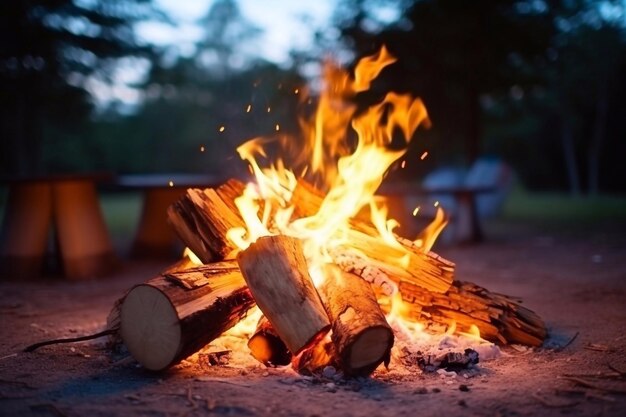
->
xmin=237 ymin=235 xmax=330 ymax=355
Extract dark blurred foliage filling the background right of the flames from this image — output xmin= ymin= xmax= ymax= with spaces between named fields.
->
xmin=338 ymin=0 xmax=626 ymax=192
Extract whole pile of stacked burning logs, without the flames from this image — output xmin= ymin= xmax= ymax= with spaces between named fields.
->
xmin=111 ymin=179 xmax=546 ymax=375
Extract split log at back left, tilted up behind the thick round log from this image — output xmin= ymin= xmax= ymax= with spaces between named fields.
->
xmin=167 ymin=180 xmax=245 ymax=263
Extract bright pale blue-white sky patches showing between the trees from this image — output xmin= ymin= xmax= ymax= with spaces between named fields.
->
xmin=97 ymin=0 xmax=337 ymax=112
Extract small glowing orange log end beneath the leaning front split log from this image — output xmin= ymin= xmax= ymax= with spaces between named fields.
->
xmin=248 ymin=316 xmax=292 ymax=365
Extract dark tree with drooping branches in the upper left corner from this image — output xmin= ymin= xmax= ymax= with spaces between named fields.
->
xmin=0 ymin=0 xmax=159 ymax=174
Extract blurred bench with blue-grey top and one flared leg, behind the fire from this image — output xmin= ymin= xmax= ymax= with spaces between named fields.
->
xmin=116 ymin=174 xmax=223 ymax=258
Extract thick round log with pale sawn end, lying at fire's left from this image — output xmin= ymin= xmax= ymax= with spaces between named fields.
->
xmin=117 ymin=261 xmax=254 ymax=371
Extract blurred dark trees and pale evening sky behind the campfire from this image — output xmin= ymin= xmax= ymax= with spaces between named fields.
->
xmin=0 ymin=0 xmax=626 ymax=244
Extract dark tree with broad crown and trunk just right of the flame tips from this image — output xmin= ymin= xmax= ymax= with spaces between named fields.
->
xmin=340 ymin=0 xmax=553 ymax=167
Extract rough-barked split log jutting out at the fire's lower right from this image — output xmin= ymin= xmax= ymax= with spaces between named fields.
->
xmin=400 ymin=281 xmax=547 ymax=346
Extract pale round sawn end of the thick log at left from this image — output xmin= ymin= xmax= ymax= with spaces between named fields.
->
xmin=120 ymin=285 xmax=182 ymax=371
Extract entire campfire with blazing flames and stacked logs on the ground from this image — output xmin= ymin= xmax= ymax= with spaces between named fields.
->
xmin=109 ymin=47 xmax=546 ymax=376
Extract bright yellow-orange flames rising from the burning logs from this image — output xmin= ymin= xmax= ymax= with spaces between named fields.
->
xmin=228 ymin=47 xmax=458 ymax=333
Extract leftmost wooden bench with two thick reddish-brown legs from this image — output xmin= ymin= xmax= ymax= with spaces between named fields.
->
xmin=0 ymin=174 xmax=117 ymax=279
